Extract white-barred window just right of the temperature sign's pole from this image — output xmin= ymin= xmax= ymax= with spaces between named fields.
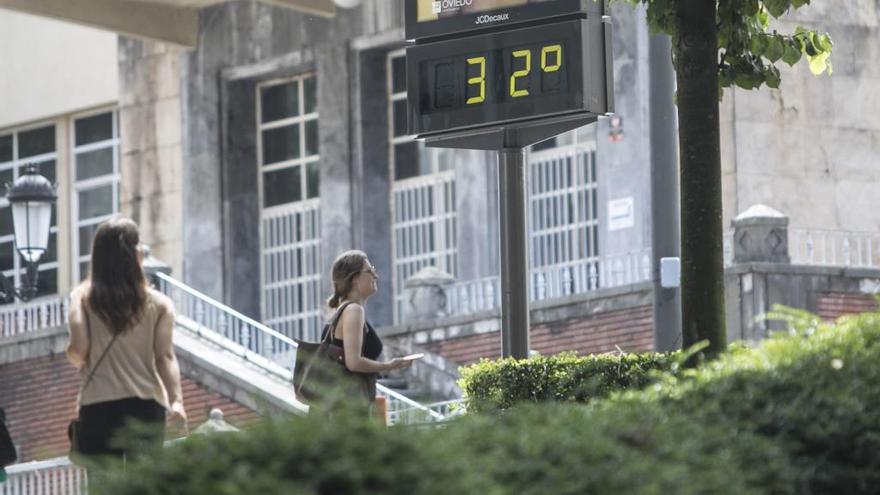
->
xmin=528 ymin=130 xmax=600 ymax=300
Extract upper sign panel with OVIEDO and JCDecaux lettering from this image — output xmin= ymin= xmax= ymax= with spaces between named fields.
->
xmin=405 ymin=0 xmax=596 ymax=40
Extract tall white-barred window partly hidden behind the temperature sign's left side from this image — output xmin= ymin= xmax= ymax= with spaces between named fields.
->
xmin=386 ymin=50 xmax=458 ymax=322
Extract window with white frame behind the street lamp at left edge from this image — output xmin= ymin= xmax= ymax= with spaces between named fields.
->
xmin=0 ymin=123 xmax=58 ymax=302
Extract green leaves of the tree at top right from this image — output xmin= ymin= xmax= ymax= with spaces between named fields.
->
xmin=626 ymin=0 xmax=834 ymax=94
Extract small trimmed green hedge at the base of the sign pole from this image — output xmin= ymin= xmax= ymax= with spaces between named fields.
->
xmin=459 ymin=352 xmax=682 ymax=412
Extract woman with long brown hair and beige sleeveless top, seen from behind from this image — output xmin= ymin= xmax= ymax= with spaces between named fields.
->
xmin=67 ymin=217 xmax=186 ymax=457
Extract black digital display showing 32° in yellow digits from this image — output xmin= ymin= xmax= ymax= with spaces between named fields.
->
xmin=407 ymin=20 xmax=605 ymax=135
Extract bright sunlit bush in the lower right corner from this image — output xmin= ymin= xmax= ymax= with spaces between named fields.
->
xmin=635 ymin=308 xmax=880 ymax=493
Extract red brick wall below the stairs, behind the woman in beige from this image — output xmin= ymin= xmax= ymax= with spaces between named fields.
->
xmin=0 ymin=355 xmax=259 ymax=462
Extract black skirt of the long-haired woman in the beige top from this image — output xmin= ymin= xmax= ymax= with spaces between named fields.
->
xmin=79 ymin=397 xmax=165 ymax=458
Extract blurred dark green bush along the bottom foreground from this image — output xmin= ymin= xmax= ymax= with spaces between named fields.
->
xmin=96 ymin=403 xmax=790 ymax=495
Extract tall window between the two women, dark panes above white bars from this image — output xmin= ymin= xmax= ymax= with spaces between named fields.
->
xmin=257 ymin=75 xmax=323 ymax=340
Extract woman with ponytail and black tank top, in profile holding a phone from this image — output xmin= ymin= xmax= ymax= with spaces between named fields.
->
xmin=321 ymin=250 xmax=412 ymax=414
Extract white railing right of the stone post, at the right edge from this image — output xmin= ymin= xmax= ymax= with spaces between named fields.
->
xmin=788 ymin=229 xmax=880 ymax=268
